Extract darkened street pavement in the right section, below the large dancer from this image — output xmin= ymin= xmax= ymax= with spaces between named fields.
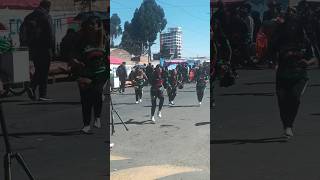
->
xmin=211 ymin=69 xmax=320 ymax=180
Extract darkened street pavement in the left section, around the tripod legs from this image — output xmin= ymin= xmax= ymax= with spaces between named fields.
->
xmin=0 ymin=82 xmax=109 ymax=180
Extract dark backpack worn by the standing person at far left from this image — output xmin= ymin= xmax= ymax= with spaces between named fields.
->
xmin=19 ymin=13 xmax=39 ymax=46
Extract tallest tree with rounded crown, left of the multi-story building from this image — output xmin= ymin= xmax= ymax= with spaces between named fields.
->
xmin=131 ymin=0 xmax=167 ymax=60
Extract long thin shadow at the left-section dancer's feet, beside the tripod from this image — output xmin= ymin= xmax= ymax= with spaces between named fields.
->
xmin=0 ymin=130 xmax=84 ymax=138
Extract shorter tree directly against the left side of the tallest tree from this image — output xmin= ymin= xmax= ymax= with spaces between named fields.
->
xmin=120 ymin=21 xmax=142 ymax=56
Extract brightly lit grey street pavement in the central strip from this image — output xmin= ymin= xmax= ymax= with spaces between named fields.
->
xmin=110 ymin=84 xmax=210 ymax=180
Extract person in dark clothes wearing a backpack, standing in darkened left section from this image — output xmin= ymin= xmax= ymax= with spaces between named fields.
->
xmin=24 ymin=0 xmax=55 ymax=101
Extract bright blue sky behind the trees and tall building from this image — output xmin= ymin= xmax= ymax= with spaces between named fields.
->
xmin=110 ymin=0 xmax=210 ymax=57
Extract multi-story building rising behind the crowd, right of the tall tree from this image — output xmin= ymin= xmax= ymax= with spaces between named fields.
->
xmin=160 ymin=27 xmax=182 ymax=58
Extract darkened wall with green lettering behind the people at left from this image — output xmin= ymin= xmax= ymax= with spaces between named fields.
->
xmin=0 ymin=0 xmax=109 ymax=54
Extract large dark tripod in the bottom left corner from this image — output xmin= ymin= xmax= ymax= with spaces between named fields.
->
xmin=0 ymin=102 xmax=34 ymax=180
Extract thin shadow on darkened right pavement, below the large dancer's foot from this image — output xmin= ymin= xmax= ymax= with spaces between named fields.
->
xmin=210 ymin=137 xmax=288 ymax=145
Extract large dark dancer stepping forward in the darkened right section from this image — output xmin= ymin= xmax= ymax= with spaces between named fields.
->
xmin=270 ymin=8 xmax=317 ymax=138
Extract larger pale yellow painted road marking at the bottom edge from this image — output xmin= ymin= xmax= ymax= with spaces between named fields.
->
xmin=111 ymin=165 xmax=201 ymax=180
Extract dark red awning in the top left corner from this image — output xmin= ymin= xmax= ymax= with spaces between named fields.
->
xmin=0 ymin=0 xmax=40 ymax=10
